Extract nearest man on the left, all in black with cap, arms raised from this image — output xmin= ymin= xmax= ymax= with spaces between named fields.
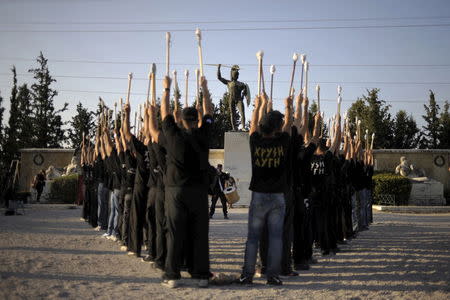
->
xmin=150 ymin=77 xmax=213 ymax=288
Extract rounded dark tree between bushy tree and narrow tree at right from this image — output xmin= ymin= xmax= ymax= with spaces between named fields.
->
xmin=392 ymin=110 xmax=420 ymax=149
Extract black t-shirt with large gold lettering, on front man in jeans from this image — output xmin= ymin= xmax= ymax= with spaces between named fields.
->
xmin=249 ymin=132 xmax=291 ymax=193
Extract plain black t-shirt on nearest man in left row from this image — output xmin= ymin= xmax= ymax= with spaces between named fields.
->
xmin=162 ymin=115 xmax=213 ymax=188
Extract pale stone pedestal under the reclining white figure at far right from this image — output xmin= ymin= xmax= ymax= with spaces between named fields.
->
xmin=408 ymin=177 xmax=445 ymax=206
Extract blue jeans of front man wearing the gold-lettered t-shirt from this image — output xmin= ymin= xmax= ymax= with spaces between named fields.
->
xmin=242 ymin=192 xmax=286 ymax=278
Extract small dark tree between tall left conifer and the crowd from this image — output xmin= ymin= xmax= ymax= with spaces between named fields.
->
xmin=67 ymin=102 xmax=95 ymax=148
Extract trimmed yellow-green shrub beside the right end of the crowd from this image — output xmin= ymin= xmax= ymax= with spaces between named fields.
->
xmin=373 ymin=173 xmax=411 ymax=205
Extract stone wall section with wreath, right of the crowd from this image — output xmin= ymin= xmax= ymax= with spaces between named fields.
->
xmin=373 ymin=149 xmax=450 ymax=197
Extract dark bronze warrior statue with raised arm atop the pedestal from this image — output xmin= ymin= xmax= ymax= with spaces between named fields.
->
xmin=217 ymin=64 xmax=250 ymax=131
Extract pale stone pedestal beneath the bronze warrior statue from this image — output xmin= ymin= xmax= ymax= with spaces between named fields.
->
xmin=224 ymin=131 xmax=252 ymax=206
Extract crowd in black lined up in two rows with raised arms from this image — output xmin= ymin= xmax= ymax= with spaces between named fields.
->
xmin=81 ymin=76 xmax=373 ymax=288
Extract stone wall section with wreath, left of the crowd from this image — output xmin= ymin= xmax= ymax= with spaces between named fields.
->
xmin=18 ymin=148 xmax=75 ymax=192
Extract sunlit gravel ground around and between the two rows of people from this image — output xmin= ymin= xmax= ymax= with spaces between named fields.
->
xmin=0 ymin=205 xmax=450 ymax=299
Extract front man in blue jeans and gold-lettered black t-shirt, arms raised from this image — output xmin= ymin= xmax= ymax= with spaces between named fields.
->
xmin=237 ymin=94 xmax=292 ymax=285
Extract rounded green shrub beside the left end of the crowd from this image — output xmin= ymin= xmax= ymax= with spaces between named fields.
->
xmin=50 ymin=174 xmax=78 ymax=204
